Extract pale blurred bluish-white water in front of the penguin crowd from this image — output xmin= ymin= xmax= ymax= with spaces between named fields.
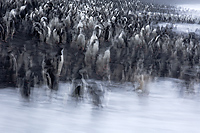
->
xmin=0 ymin=79 xmax=200 ymax=133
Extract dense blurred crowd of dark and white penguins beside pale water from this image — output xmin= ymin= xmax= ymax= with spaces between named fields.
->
xmin=0 ymin=0 xmax=200 ymax=101
